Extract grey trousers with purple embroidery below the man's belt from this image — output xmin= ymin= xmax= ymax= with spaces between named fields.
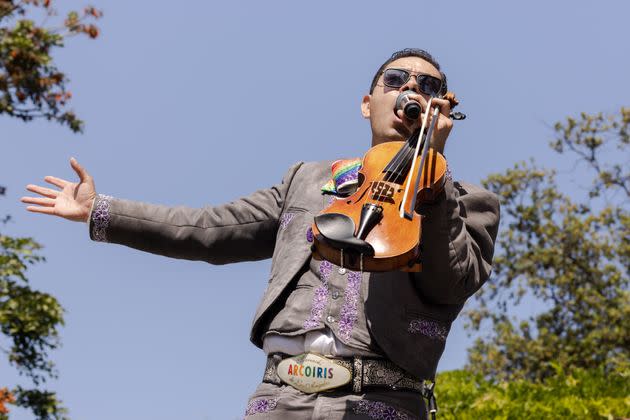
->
xmin=245 ymin=383 xmax=427 ymax=420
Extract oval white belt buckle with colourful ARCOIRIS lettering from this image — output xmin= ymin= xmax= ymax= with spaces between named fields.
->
xmin=276 ymin=353 xmax=352 ymax=394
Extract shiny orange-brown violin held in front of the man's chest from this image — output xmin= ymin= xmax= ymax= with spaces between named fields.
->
xmin=312 ymin=92 xmax=465 ymax=272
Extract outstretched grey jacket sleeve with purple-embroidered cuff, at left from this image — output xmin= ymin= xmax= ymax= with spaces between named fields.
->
xmin=89 ymin=163 xmax=301 ymax=264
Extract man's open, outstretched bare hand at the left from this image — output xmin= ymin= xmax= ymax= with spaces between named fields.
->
xmin=21 ymin=158 xmax=96 ymax=222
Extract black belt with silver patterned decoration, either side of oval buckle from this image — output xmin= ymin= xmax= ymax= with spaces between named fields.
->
xmin=263 ymin=353 xmax=424 ymax=393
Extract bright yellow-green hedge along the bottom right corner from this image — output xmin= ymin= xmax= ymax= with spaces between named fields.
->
xmin=435 ymin=369 xmax=630 ymax=420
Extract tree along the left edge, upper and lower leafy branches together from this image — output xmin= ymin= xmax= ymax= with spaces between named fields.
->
xmin=0 ymin=0 xmax=102 ymax=420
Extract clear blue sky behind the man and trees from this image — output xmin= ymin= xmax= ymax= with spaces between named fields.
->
xmin=0 ymin=1 xmax=630 ymax=420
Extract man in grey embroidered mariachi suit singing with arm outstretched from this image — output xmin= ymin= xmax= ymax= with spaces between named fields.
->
xmin=22 ymin=49 xmax=499 ymax=419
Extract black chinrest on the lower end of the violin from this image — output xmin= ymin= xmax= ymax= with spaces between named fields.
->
xmin=315 ymin=213 xmax=374 ymax=256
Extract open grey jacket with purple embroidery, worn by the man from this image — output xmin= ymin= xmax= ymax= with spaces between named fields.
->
xmin=90 ymin=162 xmax=499 ymax=378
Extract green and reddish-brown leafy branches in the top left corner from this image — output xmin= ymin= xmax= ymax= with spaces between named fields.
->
xmin=0 ymin=0 xmax=102 ymax=132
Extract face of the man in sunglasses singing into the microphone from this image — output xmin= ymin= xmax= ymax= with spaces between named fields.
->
xmin=361 ymin=57 xmax=442 ymax=146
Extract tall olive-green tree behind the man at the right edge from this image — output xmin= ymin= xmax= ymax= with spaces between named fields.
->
xmin=468 ymin=108 xmax=630 ymax=381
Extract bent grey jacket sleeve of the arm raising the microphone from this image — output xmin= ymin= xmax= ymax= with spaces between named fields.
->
xmin=414 ymin=180 xmax=499 ymax=304
